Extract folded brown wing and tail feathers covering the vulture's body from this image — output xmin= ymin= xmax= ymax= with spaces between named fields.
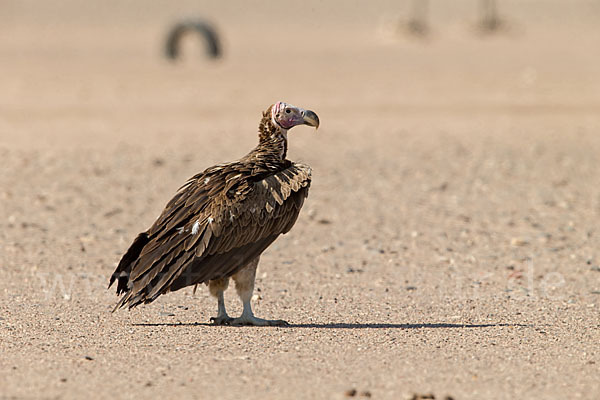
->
xmin=112 ymin=163 xmax=311 ymax=307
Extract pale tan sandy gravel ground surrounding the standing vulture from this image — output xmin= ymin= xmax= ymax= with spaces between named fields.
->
xmin=0 ymin=1 xmax=600 ymax=399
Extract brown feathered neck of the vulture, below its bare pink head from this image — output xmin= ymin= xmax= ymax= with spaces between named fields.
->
xmin=250 ymin=112 xmax=287 ymax=163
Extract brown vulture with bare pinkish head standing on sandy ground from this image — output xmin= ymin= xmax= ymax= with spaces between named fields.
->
xmin=108 ymin=102 xmax=319 ymax=326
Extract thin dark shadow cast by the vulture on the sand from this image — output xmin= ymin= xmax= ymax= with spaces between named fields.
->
xmin=132 ymin=322 xmax=531 ymax=329
